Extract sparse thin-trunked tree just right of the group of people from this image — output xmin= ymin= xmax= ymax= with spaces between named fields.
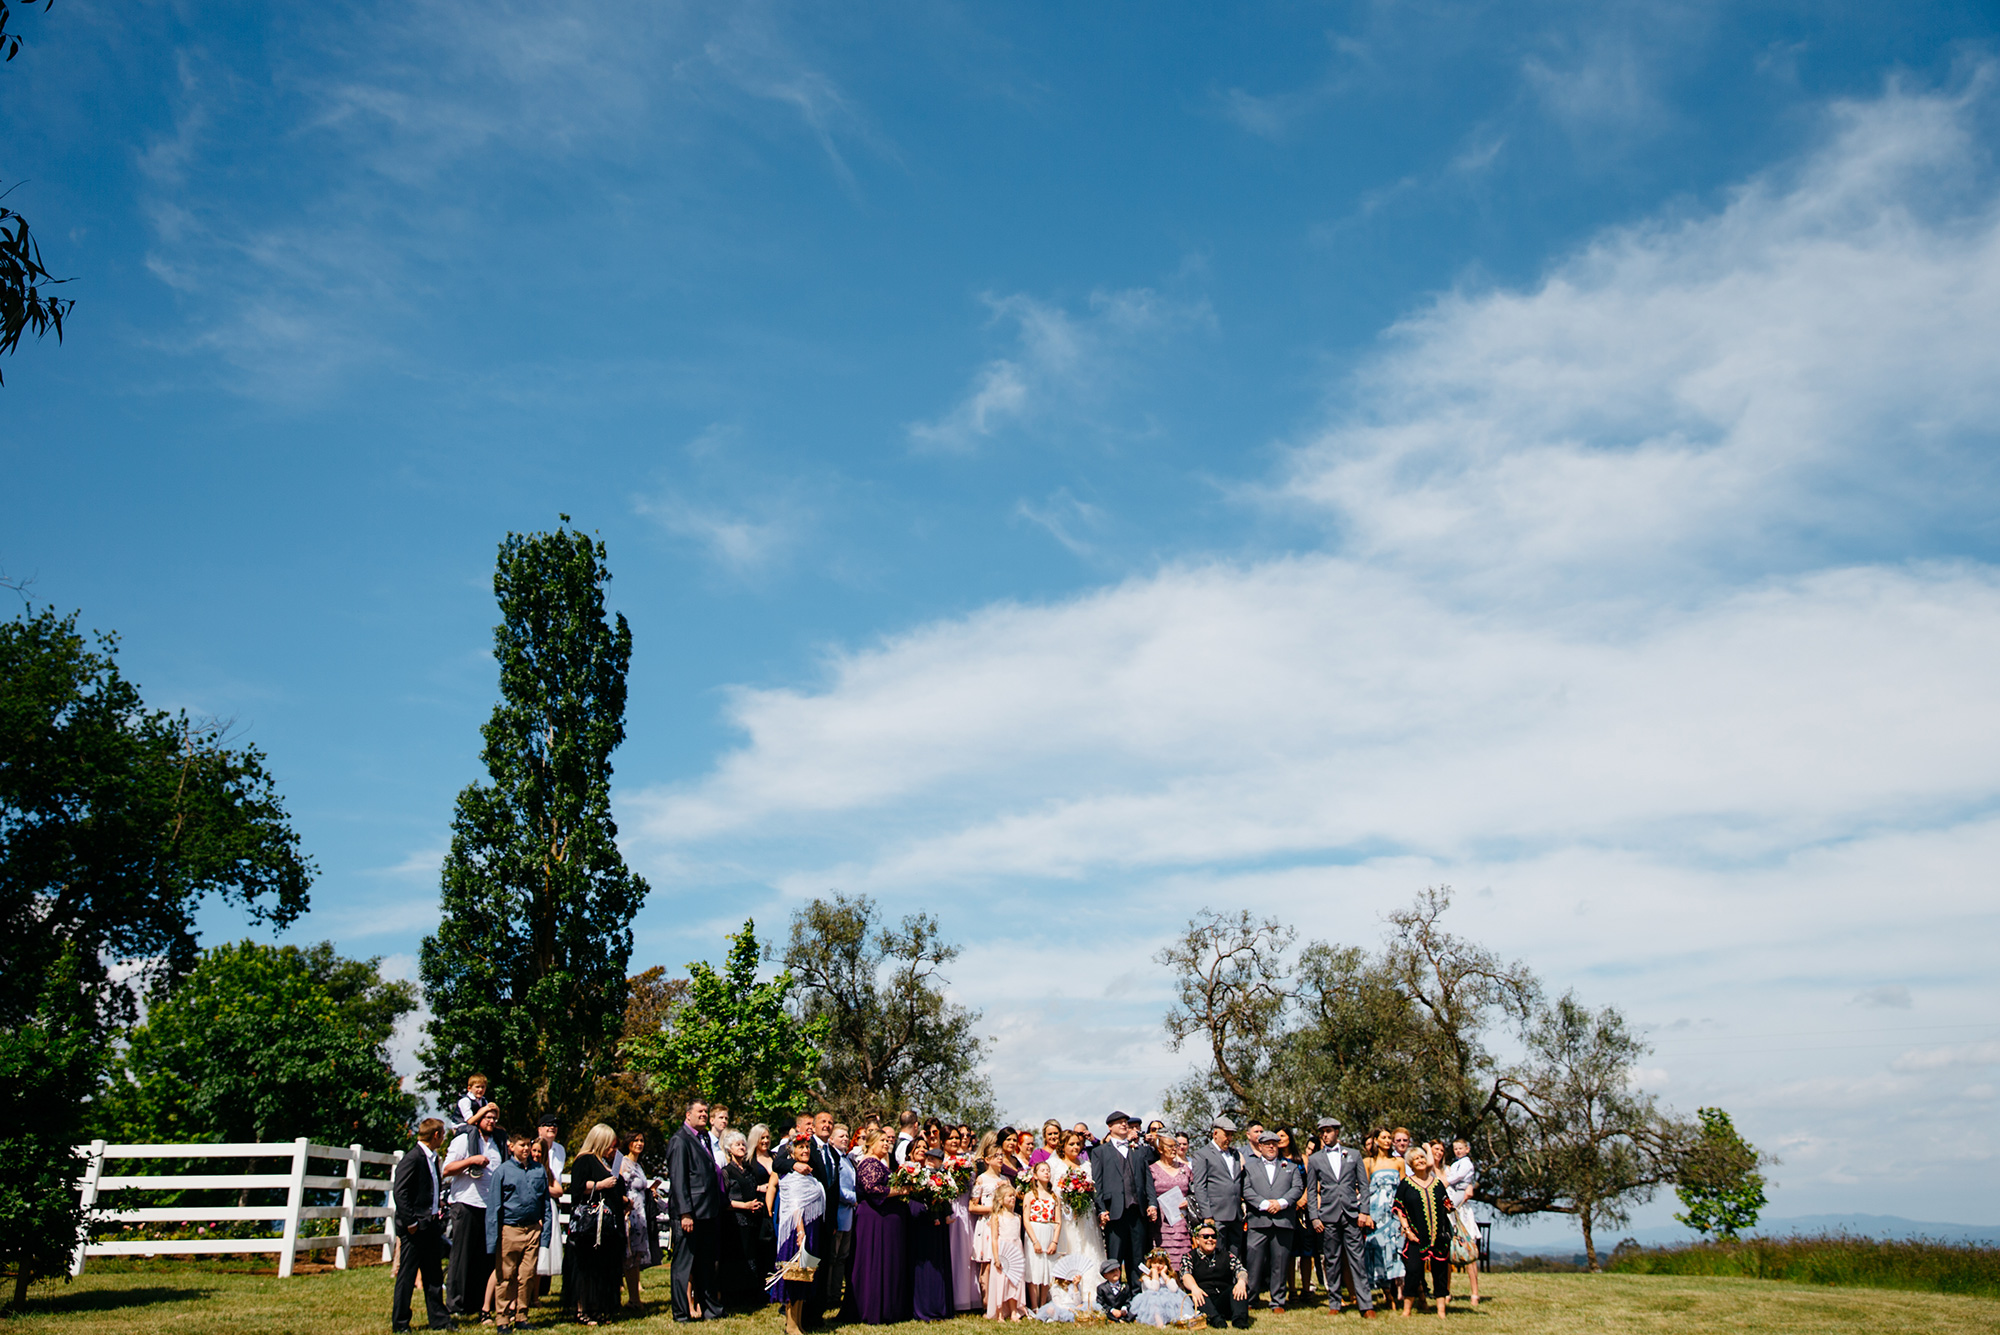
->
xmin=1504 ymin=993 xmax=1688 ymax=1271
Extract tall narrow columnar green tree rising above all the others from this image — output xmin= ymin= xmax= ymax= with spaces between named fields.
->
xmin=420 ymin=516 xmax=646 ymax=1125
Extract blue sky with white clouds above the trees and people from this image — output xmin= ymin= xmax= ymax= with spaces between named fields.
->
xmin=0 ymin=0 xmax=2000 ymax=1223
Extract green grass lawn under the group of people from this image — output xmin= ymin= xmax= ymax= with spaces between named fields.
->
xmin=6 ymin=1263 xmax=2000 ymax=1335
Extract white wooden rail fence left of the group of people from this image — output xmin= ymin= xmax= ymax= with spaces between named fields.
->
xmin=70 ymin=1137 xmax=396 ymax=1277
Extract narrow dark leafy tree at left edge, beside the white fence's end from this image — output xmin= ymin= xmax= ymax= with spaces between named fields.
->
xmin=0 ymin=943 xmax=104 ymax=1309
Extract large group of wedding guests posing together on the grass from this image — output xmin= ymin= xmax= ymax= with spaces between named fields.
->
xmin=392 ymin=1089 xmax=1478 ymax=1335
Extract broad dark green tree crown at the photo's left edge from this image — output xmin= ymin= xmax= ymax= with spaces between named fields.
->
xmin=0 ymin=612 xmax=312 ymax=1029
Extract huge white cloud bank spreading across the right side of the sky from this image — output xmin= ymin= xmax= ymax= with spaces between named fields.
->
xmin=628 ymin=90 xmax=2000 ymax=1191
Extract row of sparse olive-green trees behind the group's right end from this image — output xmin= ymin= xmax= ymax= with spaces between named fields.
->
xmin=1156 ymin=887 xmax=1768 ymax=1269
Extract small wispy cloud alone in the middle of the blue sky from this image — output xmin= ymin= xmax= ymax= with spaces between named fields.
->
xmin=908 ymin=288 xmax=1214 ymax=454
